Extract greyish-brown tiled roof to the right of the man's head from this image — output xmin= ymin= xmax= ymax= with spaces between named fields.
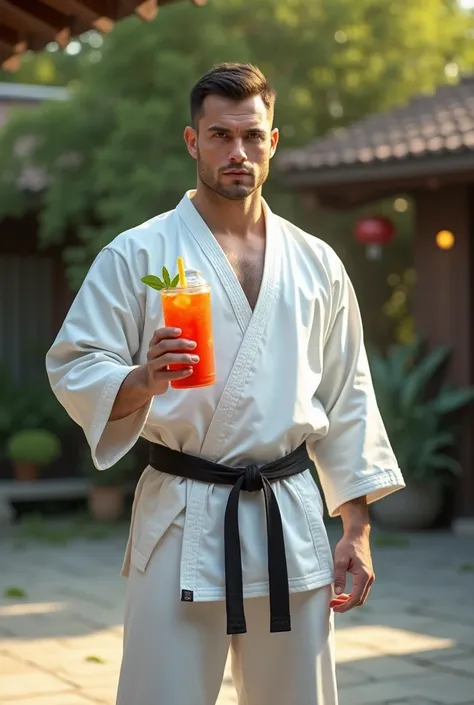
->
xmin=278 ymin=76 xmax=474 ymax=173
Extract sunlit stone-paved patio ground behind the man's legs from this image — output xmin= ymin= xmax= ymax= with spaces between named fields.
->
xmin=0 ymin=520 xmax=474 ymax=705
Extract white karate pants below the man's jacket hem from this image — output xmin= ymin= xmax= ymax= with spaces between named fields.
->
xmin=117 ymin=525 xmax=337 ymax=705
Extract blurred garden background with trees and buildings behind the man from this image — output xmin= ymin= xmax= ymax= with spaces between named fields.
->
xmin=0 ymin=0 xmax=474 ymax=530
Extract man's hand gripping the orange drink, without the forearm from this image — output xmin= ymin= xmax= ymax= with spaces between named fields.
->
xmin=146 ymin=328 xmax=199 ymax=396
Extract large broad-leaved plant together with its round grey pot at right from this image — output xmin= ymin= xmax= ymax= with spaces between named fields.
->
xmin=370 ymin=338 xmax=474 ymax=530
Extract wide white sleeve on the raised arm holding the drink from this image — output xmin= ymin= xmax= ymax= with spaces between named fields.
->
xmin=46 ymin=249 xmax=151 ymax=470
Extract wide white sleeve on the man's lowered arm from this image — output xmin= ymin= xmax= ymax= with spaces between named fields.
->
xmin=308 ymin=263 xmax=405 ymax=517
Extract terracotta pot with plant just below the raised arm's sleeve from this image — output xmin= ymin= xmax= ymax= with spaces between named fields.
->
xmin=81 ymin=449 xmax=135 ymax=522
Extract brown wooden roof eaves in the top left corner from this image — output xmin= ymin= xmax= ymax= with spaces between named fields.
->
xmin=0 ymin=0 xmax=207 ymax=71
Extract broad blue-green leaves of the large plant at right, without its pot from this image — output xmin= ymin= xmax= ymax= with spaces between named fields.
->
xmin=369 ymin=338 xmax=474 ymax=485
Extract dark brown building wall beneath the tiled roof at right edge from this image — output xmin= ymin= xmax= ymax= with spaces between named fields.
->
xmin=414 ymin=183 xmax=474 ymax=517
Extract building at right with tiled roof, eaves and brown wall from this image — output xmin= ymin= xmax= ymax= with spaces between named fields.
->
xmin=278 ymin=76 xmax=474 ymax=519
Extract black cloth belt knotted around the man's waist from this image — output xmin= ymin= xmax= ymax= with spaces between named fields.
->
xmin=150 ymin=443 xmax=312 ymax=634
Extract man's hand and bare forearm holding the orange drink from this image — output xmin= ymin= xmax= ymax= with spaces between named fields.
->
xmin=109 ymin=328 xmax=199 ymax=421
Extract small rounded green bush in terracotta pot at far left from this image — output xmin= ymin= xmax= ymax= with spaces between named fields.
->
xmin=6 ymin=429 xmax=61 ymax=482
